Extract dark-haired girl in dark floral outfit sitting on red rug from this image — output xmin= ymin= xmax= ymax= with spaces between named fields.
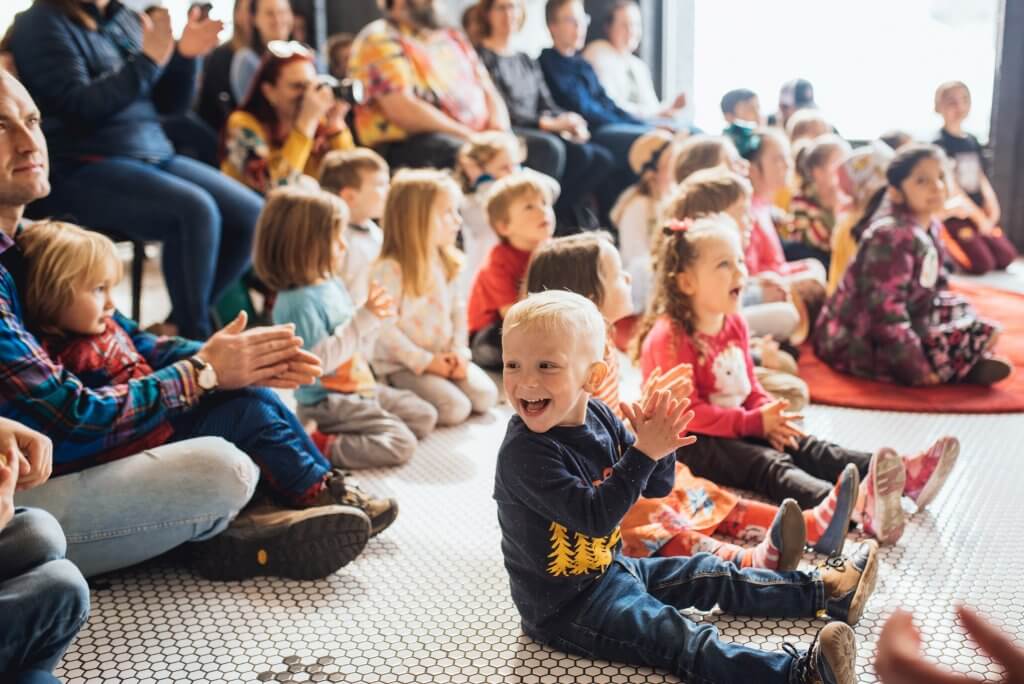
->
xmin=814 ymin=144 xmax=1012 ymax=385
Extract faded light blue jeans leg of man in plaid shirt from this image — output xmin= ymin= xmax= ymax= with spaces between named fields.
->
xmin=16 ymin=437 xmax=259 ymax=576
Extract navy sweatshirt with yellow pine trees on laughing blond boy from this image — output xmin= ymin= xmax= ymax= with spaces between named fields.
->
xmin=495 ymin=399 xmax=676 ymax=634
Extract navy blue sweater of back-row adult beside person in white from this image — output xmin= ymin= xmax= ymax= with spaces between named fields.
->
xmin=538 ymin=47 xmax=644 ymax=129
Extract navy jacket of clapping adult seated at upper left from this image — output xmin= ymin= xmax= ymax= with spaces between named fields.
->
xmin=11 ymin=0 xmax=199 ymax=161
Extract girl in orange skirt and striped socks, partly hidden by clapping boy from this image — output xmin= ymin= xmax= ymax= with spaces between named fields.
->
xmin=526 ymin=232 xmax=860 ymax=570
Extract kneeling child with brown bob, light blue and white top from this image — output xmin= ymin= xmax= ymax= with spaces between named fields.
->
xmin=253 ymin=187 xmax=437 ymax=475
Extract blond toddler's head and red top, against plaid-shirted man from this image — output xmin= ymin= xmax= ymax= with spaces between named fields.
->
xmin=17 ymin=221 xmax=169 ymax=459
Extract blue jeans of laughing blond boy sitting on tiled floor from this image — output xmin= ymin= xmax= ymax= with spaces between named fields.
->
xmin=524 ymin=553 xmax=825 ymax=684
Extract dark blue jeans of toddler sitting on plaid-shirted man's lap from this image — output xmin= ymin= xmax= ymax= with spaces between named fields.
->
xmin=171 ymin=388 xmax=331 ymax=504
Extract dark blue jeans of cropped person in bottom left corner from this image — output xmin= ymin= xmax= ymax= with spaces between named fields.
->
xmin=0 ymin=508 xmax=89 ymax=681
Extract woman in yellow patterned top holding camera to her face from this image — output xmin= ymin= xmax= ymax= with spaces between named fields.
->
xmin=220 ymin=41 xmax=355 ymax=195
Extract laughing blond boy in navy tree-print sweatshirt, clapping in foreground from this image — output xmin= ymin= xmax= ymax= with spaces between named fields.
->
xmin=495 ymin=291 xmax=878 ymax=684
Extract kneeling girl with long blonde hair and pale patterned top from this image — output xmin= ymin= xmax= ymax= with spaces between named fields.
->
xmin=371 ymin=169 xmax=498 ymax=425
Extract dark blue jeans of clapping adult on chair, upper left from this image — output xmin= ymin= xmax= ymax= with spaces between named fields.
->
xmin=37 ymin=155 xmax=263 ymax=340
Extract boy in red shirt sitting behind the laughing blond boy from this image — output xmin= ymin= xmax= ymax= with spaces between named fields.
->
xmin=469 ymin=171 xmax=555 ymax=371
